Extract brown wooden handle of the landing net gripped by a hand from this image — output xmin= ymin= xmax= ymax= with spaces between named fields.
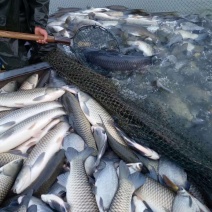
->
xmin=0 ymin=30 xmax=55 ymax=43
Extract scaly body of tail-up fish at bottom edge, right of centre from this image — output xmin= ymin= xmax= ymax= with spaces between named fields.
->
xmin=109 ymin=180 xmax=134 ymax=212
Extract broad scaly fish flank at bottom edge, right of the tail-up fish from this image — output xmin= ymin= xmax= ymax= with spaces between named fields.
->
xmin=135 ymin=178 xmax=176 ymax=212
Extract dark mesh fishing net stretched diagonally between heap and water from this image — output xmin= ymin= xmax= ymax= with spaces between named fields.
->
xmin=44 ymin=49 xmax=212 ymax=203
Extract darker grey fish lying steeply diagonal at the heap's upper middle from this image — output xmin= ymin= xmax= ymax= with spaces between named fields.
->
xmin=62 ymin=93 xmax=97 ymax=155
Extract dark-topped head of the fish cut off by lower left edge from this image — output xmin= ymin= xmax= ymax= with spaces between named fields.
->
xmin=0 ymin=159 xmax=23 ymax=177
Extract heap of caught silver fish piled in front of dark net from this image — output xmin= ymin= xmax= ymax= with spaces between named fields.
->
xmin=0 ymin=71 xmax=210 ymax=212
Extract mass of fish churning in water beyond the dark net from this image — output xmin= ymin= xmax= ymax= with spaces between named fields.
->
xmin=48 ymin=5 xmax=212 ymax=163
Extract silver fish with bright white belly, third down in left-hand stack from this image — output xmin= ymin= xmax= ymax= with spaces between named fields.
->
xmin=0 ymin=108 xmax=65 ymax=153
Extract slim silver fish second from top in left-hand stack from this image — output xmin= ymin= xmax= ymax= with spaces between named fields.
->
xmin=0 ymin=102 xmax=62 ymax=133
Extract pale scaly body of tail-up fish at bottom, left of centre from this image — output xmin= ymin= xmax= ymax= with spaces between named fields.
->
xmin=66 ymin=160 xmax=99 ymax=212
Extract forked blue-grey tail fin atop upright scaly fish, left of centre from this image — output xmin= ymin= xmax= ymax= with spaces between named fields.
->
xmin=65 ymin=147 xmax=94 ymax=162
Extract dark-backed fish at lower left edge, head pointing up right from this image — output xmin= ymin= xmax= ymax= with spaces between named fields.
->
xmin=0 ymin=159 xmax=23 ymax=204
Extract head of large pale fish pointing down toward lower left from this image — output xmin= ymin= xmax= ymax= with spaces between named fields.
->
xmin=12 ymin=166 xmax=31 ymax=194
